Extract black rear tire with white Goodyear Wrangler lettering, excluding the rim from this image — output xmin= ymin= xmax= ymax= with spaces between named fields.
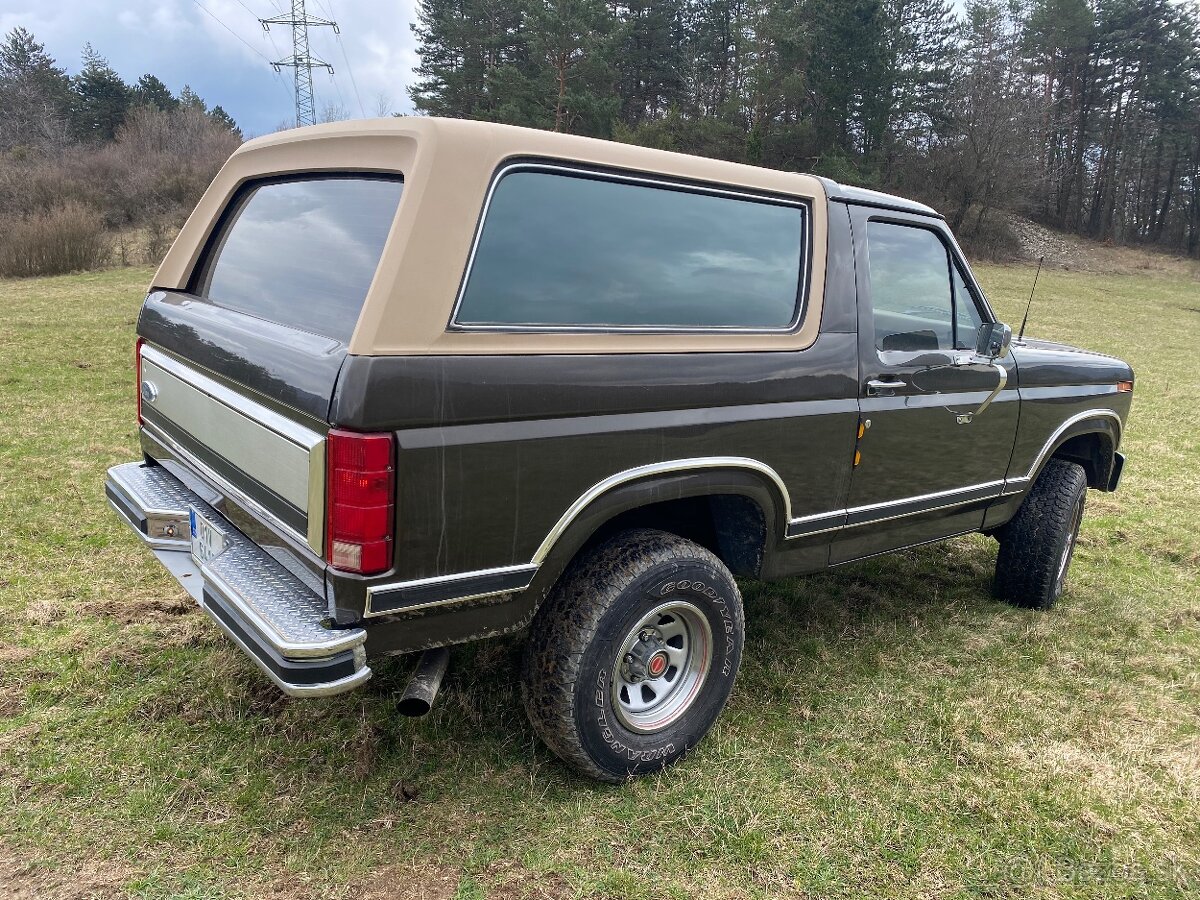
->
xmin=521 ymin=529 xmax=745 ymax=784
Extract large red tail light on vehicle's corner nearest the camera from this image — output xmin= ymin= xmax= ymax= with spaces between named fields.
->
xmin=325 ymin=428 xmax=396 ymax=575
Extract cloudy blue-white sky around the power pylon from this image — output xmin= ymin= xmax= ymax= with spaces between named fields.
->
xmin=0 ymin=0 xmax=418 ymax=138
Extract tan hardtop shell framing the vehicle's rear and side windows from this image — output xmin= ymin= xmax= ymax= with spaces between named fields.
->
xmin=154 ymin=116 xmax=827 ymax=354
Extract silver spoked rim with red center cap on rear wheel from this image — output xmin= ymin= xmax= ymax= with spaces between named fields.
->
xmin=612 ymin=600 xmax=713 ymax=734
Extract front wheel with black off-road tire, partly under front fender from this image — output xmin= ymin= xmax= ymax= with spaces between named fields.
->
xmin=995 ymin=460 xmax=1087 ymax=610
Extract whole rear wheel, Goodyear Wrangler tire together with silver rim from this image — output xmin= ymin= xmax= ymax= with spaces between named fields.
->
xmin=522 ymin=529 xmax=744 ymax=782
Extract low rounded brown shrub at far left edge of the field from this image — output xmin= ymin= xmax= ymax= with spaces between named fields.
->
xmin=0 ymin=200 xmax=110 ymax=277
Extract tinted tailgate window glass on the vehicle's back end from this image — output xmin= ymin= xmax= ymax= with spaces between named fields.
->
xmin=196 ymin=176 xmax=403 ymax=342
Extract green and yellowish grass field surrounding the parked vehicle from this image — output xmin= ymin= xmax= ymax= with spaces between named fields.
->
xmin=0 ymin=256 xmax=1200 ymax=900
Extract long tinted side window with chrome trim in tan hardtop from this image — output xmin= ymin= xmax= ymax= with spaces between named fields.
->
xmin=455 ymin=169 xmax=806 ymax=330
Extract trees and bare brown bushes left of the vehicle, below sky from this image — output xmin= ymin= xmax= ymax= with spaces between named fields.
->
xmin=0 ymin=28 xmax=242 ymax=275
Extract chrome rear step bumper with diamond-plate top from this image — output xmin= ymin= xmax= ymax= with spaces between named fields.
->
xmin=104 ymin=462 xmax=371 ymax=697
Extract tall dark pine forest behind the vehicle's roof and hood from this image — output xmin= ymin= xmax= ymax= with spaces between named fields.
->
xmin=410 ymin=0 xmax=1200 ymax=256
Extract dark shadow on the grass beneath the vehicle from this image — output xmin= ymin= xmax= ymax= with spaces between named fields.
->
xmin=333 ymin=535 xmax=1007 ymax=790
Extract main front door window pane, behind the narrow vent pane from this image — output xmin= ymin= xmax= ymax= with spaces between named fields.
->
xmin=866 ymin=222 xmax=955 ymax=352
